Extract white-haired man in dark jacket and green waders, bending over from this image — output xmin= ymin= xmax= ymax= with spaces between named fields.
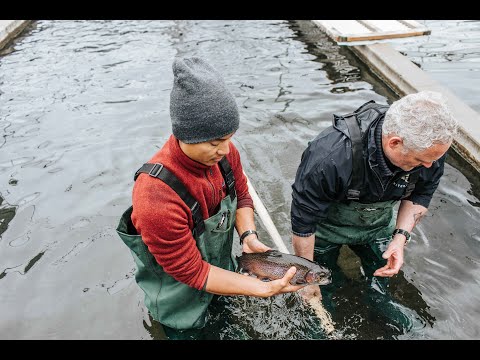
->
xmin=291 ymin=91 xmax=457 ymax=330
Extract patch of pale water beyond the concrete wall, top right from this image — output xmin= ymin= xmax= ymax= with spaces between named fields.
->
xmin=392 ymin=20 xmax=480 ymax=112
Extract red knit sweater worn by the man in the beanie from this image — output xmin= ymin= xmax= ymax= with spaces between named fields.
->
xmin=132 ymin=135 xmax=253 ymax=290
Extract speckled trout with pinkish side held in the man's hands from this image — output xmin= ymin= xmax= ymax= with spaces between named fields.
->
xmin=236 ymin=250 xmax=332 ymax=285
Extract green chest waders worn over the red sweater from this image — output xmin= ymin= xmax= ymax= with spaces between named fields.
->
xmin=117 ymin=158 xmax=237 ymax=330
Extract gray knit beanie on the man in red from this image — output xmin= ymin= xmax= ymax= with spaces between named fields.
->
xmin=170 ymin=57 xmax=239 ymax=144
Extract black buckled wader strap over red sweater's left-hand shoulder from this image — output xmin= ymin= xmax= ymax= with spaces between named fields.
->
xmin=133 ymin=163 xmax=205 ymax=235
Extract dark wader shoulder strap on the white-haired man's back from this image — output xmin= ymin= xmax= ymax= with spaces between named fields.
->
xmin=345 ymin=114 xmax=365 ymax=200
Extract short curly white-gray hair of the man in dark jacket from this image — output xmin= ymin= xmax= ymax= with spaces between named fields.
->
xmin=382 ymin=91 xmax=458 ymax=151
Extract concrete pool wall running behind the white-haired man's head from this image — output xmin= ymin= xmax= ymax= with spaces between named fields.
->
xmin=349 ymin=44 xmax=480 ymax=172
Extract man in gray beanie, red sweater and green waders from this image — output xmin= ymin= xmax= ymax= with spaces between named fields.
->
xmin=117 ymin=57 xmax=304 ymax=339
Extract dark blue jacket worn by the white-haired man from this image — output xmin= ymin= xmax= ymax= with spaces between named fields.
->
xmin=291 ymin=101 xmax=446 ymax=236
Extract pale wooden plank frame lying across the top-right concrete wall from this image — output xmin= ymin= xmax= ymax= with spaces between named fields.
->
xmin=312 ymin=20 xmax=431 ymax=45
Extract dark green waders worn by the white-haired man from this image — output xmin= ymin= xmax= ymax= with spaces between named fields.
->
xmin=314 ymin=200 xmax=418 ymax=330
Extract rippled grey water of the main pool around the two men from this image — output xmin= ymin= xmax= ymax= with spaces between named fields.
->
xmin=0 ymin=20 xmax=480 ymax=339
